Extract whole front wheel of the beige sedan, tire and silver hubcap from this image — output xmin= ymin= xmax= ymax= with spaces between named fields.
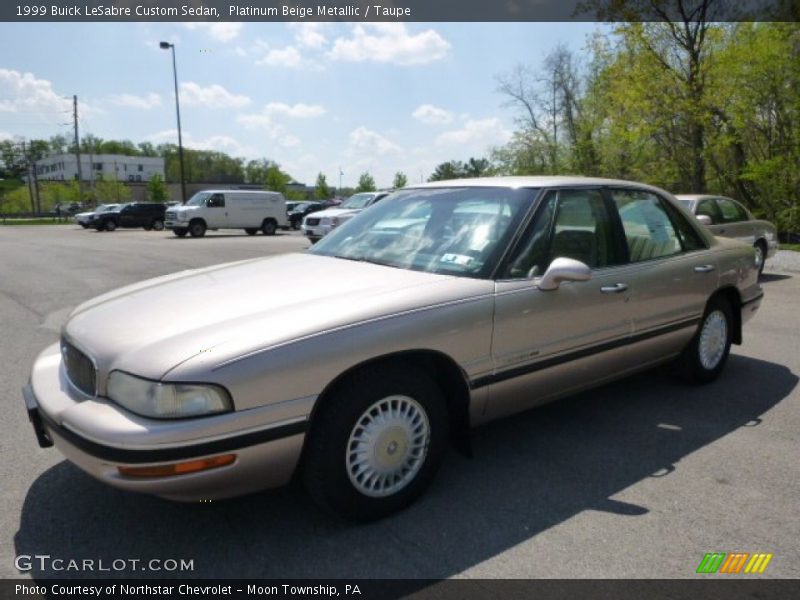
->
xmin=303 ymin=365 xmax=448 ymax=522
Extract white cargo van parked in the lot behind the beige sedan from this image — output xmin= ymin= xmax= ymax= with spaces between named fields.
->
xmin=164 ymin=190 xmax=289 ymax=237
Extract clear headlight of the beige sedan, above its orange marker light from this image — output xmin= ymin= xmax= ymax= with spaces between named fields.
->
xmin=106 ymin=371 xmax=233 ymax=419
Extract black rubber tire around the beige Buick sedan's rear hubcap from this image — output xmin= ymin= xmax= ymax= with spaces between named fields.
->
xmin=677 ymin=296 xmax=734 ymax=383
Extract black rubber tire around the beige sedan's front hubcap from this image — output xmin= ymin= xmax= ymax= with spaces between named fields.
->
xmin=303 ymin=364 xmax=448 ymax=522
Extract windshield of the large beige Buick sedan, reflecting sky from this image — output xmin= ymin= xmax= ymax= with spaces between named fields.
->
xmin=310 ymin=187 xmax=536 ymax=278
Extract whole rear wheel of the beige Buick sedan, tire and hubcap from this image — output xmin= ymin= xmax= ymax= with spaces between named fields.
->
xmin=678 ymin=297 xmax=733 ymax=383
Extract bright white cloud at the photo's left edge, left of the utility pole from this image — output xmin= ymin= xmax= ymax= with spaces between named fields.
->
xmin=0 ymin=69 xmax=72 ymax=116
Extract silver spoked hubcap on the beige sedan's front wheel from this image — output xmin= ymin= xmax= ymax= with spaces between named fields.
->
xmin=346 ymin=396 xmax=430 ymax=498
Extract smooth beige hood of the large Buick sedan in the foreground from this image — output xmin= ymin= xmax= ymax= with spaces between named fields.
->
xmin=63 ymin=254 xmax=492 ymax=389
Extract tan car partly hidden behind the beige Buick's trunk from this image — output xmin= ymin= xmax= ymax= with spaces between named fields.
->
xmin=675 ymin=194 xmax=778 ymax=273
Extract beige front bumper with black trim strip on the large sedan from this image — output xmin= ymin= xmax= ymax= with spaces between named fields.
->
xmin=23 ymin=344 xmax=307 ymax=502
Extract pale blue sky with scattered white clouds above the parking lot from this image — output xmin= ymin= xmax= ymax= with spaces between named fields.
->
xmin=0 ymin=22 xmax=595 ymax=186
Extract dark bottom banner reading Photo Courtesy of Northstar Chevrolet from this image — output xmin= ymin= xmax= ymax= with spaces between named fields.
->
xmin=0 ymin=576 xmax=800 ymax=600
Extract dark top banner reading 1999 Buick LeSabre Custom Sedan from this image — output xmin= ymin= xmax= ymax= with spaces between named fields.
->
xmin=0 ymin=0 xmax=800 ymax=22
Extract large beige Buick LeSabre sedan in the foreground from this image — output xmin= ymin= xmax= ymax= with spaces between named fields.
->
xmin=24 ymin=177 xmax=762 ymax=520
